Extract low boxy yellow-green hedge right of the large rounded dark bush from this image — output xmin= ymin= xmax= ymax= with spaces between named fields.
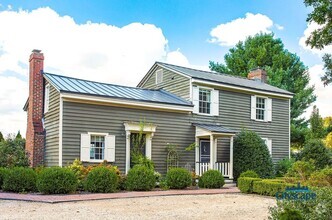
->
xmin=252 ymin=179 xmax=294 ymax=196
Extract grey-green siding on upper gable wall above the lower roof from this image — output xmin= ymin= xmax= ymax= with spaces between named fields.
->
xmin=141 ymin=67 xmax=190 ymax=100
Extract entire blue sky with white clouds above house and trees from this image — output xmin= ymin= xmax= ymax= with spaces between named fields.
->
xmin=0 ymin=0 xmax=332 ymax=136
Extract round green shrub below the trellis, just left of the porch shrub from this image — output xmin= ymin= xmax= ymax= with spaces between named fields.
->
xmin=166 ymin=168 xmax=192 ymax=189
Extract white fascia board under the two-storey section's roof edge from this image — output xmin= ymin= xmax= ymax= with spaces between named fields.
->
xmin=192 ymin=78 xmax=293 ymax=99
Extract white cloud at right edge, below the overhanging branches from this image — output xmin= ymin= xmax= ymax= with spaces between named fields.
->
xmin=304 ymin=64 xmax=332 ymax=118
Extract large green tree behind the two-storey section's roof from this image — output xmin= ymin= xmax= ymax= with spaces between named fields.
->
xmin=210 ymin=34 xmax=316 ymax=127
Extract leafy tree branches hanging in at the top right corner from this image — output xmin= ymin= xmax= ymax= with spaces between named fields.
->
xmin=304 ymin=0 xmax=332 ymax=85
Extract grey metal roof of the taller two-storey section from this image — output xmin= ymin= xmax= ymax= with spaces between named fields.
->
xmin=156 ymin=62 xmax=293 ymax=95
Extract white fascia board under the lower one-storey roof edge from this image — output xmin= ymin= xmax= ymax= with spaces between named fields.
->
xmin=62 ymin=93 xmax=193 ymax=112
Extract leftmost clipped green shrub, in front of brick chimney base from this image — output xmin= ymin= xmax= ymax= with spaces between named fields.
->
xmin=2 ymin=167 xmax=37 ymax=192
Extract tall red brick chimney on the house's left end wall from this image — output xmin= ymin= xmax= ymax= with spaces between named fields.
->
xmin=25 ymin=50 xmax=44 ymax=167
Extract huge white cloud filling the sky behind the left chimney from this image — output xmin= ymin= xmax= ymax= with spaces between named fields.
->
xmin=0 ymin=8 xmax=189 ymax=137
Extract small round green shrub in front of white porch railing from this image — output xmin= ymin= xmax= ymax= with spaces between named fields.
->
xmin=198 ymin=170 xmax=225 ymax=189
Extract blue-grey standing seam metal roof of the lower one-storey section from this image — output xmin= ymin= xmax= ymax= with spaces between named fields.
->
xmin=44 ymin=73 xmax=192 ymax=106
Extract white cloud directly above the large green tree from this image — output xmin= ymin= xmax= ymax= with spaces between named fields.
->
xmin=210 ymin=13 xmax=273 ymax=46
